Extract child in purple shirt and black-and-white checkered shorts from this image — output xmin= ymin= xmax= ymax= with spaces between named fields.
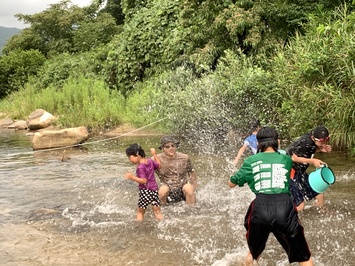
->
xmin=125 ymin=143 xmax=163 ymax=221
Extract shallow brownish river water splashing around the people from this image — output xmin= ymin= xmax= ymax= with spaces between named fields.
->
xmin=0 ymin=130 xmax=355 ymax=266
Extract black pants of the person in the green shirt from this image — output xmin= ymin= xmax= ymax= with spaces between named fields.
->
xmin=244 ymin=194 xmax=311 ymax=263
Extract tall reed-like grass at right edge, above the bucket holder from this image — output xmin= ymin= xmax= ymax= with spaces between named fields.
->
xmin=271 ymin=6 xmax=355 ymax=150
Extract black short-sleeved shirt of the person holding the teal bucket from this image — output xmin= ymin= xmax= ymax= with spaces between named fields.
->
xmin=286 ymin=132 xmax=317 ymax=173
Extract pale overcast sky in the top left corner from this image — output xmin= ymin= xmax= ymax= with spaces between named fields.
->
xmin=0 ymin=0 xmax=91 ymax=29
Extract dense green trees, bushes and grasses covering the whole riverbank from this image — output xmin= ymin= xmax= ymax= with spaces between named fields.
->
xmin=0 ymin=0 xmax=355 ymax=153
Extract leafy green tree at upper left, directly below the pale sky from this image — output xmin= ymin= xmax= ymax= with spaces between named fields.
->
xmin=3 ymin=0 xmax=119 ymax=57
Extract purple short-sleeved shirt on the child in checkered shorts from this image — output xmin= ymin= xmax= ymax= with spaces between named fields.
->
xmin=136 ymin=158 xmax=159 ymax=191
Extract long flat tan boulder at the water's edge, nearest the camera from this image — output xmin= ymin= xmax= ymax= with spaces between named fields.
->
xmin=32 ymin=126 xmax=89 ymax=150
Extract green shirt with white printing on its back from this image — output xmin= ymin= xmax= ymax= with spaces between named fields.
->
xmin=230 ymin=152 xmax=292 ymax=194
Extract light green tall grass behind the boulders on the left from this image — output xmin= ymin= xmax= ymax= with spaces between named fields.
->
xmin=0 ymin=77 xmax=125 ymax=129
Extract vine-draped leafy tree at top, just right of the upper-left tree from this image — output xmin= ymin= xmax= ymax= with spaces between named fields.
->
xmin=105 ymin=0 xmax=185 ymax=95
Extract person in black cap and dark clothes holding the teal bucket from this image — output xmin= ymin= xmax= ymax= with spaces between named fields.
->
xmin=286 ymin=125 xmax=332 ymax=211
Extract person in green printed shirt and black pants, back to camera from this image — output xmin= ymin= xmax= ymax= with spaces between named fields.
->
xmin=229 ymin=127 xmax=313 ymax=266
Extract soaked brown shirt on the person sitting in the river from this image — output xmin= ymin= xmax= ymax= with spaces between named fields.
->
xmin=156 ymin=152 xmax=193 ymax=189
